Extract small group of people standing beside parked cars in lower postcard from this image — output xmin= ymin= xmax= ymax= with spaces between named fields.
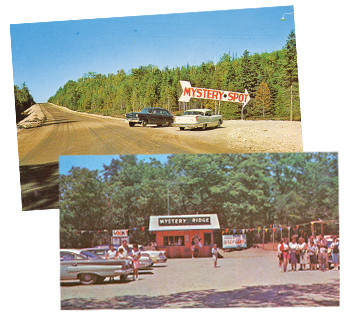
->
xmin=106 ymin=240 xmax=141 ymax=280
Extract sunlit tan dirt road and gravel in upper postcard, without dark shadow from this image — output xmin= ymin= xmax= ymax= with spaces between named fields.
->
xmin=18 ymin=104 xmax=306 ymax=165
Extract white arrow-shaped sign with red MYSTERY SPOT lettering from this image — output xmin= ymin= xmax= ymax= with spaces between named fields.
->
xmin=179 ymin=80 xmax=250 ymax=107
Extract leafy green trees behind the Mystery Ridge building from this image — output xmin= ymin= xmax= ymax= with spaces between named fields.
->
xmin=58 ymin=151 xmax=341 ymax=247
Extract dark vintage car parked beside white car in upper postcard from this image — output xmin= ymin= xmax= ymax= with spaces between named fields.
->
xmin=125 ymin=107 xmax=173 ymax=127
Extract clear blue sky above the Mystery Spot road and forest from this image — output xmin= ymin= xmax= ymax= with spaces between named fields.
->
xmin=10 ymin=6 xmax=306 ymax=103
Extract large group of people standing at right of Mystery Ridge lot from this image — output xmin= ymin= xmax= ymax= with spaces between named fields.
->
xmin=277 ymin=235 xmax=339 ymax=272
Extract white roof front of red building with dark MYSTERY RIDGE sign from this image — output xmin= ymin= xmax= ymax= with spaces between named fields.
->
xmin=149 ymin=214 xmax=220 ymax=231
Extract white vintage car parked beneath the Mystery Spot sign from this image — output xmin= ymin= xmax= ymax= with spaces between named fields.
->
xmin=173 ymin=109 xmax=223 ymax=130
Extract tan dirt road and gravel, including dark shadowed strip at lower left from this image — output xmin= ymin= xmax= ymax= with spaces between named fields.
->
xmin=11 ymin=104 xmax=306 ymax=210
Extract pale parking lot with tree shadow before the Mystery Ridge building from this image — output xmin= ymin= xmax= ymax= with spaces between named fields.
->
xmin=58 ymin=249 xmax=341 ymax=310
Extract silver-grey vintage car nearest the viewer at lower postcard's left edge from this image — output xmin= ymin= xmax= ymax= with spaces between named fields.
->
xmin=58 ymin=249 xmax=134 ymax=285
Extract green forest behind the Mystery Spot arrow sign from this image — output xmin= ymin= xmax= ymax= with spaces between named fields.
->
xmin=48 ymin=31 xmax=301 ymax=120
